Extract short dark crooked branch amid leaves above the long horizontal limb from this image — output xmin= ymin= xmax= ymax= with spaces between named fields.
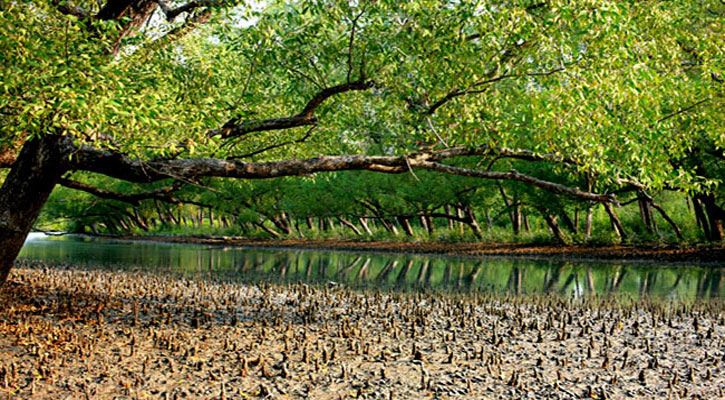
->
xmin=207 ymin=79 xmax=373 ymax=138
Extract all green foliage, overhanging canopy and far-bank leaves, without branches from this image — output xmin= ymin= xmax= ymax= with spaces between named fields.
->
xmin=0 ymin=0 xmax=725 ymax=242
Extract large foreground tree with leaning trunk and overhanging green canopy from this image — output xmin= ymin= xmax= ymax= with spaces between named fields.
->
xmin=0 ymin=0 xmax=724 ymax=282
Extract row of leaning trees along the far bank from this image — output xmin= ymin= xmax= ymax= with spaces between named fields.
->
xmin=40 ymin=172 xmax=720 ymax=244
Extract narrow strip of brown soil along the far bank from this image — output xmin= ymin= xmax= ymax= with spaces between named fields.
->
xmin=111 ymin=236 xmax=725 ymax=265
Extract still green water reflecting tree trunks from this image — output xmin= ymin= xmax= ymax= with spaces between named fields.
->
xmin=20 ymin=234 xmax=725 ymax=299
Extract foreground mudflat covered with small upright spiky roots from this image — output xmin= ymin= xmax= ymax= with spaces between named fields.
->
xmin=0 ymin=265 xmax=725 ymax=399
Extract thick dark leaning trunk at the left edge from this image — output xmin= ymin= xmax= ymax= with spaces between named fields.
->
xmin=0 ymin=135 xmax=73 ymax=286
